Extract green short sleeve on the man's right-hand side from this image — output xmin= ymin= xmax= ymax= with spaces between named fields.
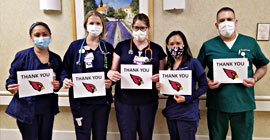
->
xmin=253 ymin=40 xmax=269 ymax=68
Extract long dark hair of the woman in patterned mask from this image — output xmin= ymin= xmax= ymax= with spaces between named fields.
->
xmin=166 ymin=31 xmax=192 ymax=69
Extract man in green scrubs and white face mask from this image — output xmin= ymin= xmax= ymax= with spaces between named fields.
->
xmin=198 ymin=7 xmax=269 ymax=140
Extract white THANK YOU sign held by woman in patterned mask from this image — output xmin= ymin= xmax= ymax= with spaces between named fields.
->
xmin=159 ymin=70 xmax=192 ymax=95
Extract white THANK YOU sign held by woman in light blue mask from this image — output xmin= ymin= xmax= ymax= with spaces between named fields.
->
xmin=17 ymin=69 xmax=53 ymax=98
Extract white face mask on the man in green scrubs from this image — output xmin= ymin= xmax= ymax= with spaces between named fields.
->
xmin=218 ymin=21 xmax=235 ymax=37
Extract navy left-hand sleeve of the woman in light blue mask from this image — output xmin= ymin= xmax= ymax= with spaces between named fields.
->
xmin=6 ymin=52 xmax=25 ymax=89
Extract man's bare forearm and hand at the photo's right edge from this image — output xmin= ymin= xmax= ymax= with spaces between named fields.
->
xmin=243 ymin=65 xmax=267 ymax=87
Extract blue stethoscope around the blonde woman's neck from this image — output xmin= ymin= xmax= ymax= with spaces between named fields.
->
xmin=76 ymin=39 xmax=110 ymax=68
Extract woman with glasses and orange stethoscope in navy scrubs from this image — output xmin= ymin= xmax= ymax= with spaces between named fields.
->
xmin=108 ymin=14 xmax=166 ymax=140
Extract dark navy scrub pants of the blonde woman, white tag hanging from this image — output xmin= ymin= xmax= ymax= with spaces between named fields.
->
xmin=72 ymin=103 xmax=111 ymax=140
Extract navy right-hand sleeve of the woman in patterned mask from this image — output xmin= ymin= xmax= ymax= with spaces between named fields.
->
xmin=185 ymin=61 xmax=208 ymax=103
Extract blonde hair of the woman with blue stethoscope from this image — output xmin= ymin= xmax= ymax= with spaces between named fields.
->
xmin=83 ymin=10 xmax=106 ymax=38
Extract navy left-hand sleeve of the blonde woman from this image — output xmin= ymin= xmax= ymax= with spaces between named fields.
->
xmin=60 ymin=43 xmax=75 ymax=83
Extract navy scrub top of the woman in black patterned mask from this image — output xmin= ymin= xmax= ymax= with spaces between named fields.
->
xmin=163 ymin=58 xmax=208 ymax=121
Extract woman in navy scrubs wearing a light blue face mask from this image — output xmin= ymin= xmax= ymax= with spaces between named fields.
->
xmin=6 ymin=22 xmax=62 ymax=140
